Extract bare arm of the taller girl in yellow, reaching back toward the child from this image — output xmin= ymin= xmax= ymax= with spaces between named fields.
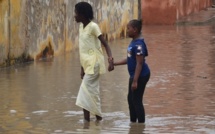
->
xmin=98 ymin=35 xmax=114 ymax=71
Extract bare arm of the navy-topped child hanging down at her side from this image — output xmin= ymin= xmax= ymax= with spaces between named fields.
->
xmin=131 ymin=55 xmax=144 ymax=90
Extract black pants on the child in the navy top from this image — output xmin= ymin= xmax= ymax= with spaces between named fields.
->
xmin=128 ymin=74 xmax=150 ymax=123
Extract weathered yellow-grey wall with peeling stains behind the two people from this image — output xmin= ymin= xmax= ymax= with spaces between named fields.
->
xmin=0 ymin=0 xmax=138 ymax=66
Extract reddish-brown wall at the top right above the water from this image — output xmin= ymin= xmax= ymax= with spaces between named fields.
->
xmin=142 ymin=0 xmax=212 ymax=24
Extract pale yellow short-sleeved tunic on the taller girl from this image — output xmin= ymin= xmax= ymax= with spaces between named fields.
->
xmin=79 ymin=21 xmax=106 ymax=74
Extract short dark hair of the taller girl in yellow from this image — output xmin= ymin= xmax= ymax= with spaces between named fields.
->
xmin=75 ymin=2 xmax=94 ymax=20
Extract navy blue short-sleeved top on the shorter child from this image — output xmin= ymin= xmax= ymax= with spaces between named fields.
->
xmin=127 ymin=39 xmax=150 ymax=78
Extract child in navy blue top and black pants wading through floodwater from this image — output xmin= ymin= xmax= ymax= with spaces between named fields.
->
xmin=114 ymin=20 xmax=150 ymax=123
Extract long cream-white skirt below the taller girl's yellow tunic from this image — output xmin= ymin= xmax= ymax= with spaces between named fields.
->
xmin=76 ymin=63 xmax=102 ymax=116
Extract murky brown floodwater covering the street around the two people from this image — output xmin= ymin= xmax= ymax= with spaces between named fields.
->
xmin=0 ymin=25 xmax=215 ymax=134
